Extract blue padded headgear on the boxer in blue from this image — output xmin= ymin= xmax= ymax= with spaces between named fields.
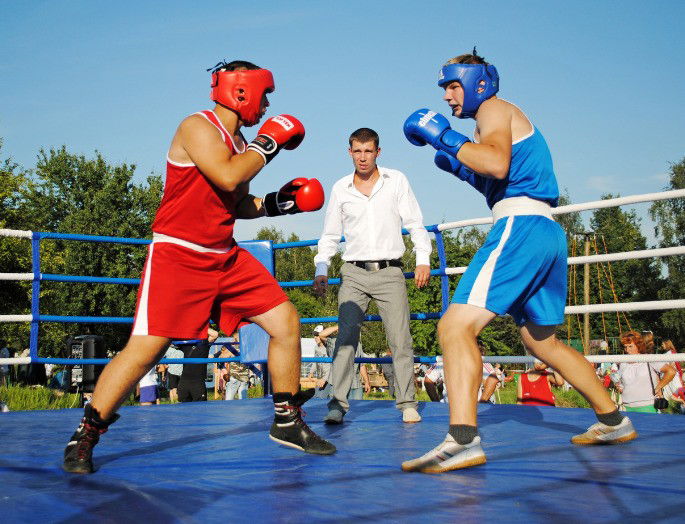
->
xmin=438 ymin=64 xmax=499 ymax=118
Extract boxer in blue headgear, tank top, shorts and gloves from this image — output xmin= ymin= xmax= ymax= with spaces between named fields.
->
xmin=402 ymin=48 xmax=637 ymax=473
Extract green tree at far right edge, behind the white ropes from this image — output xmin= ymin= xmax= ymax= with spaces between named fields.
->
xmin=649 ymin=158 xmax=685 ymax=348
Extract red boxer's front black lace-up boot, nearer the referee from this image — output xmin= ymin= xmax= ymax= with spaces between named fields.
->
xmin=269 ymin=389 xmax=336 ymax=455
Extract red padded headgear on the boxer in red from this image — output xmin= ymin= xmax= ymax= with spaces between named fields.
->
xmin=209 ymin=69 xmax=275 ymax=126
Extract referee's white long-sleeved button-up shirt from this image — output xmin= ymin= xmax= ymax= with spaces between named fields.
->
xmin=314 ymin=166 xmax=431 ymax=276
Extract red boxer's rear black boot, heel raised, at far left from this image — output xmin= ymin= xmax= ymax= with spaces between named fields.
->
xmin=62 ymin=404 xmax=119 ymax=473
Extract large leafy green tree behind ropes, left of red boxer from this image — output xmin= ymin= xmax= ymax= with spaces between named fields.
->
xmin=6 ymin=147 xmax=162 ymax=356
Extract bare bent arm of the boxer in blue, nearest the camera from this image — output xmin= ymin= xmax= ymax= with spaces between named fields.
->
xmin=457 ymin=100 xmax=511 ymax=180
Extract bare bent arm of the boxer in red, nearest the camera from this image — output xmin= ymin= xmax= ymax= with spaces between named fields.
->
xmin=179 ymin=115 xmax=264 ymax=191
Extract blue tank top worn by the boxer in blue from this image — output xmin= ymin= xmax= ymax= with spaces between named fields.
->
xmin=457 ymin=126 xmax=559 ymax=209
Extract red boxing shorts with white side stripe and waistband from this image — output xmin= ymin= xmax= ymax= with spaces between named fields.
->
xmin=131 ymin=235 xmax=288 ymax=339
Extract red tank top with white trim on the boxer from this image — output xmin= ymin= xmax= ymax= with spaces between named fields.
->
xmin=152 ymin=111 xmax=244 ymax=249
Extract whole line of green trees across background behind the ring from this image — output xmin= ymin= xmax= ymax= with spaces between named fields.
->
xmin=0 ymin=137 xmax=685 ymax=356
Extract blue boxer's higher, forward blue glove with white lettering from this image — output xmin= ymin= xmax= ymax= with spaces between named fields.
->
xmin=404 ymin=109 xmax=470 ymax=157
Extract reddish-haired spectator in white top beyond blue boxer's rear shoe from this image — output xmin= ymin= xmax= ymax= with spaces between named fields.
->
xmin=612 ymin=331 xmax=675 ymax=413
